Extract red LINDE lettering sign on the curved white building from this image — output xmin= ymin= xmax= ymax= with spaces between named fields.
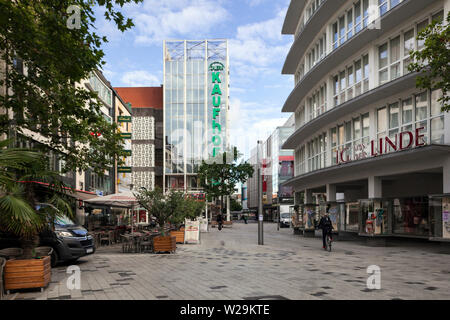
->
xmin=336 ymin=127 xmax=425 ymax=164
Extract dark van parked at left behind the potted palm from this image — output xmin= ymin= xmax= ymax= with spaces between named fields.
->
xmin=0 ymin=217 xmax=95 ymax=267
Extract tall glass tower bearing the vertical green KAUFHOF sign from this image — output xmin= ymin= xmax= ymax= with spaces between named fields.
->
xmin=163 ymin=39 xmax=229 ymax=197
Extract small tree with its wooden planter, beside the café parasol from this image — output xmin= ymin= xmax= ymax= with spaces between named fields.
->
xmin=134 ymin=187 xmax=183 ymax=252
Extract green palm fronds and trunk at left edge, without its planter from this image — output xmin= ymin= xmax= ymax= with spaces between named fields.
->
xmin=0 ymin=140 xmax=73 ymax=258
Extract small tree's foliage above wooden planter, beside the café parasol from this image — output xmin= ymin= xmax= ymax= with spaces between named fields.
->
xmin=134 ymin=187 xmax=183 ymax=236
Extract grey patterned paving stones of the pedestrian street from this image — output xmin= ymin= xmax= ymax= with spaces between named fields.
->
xmin=6 ymin=223 xmax=450 ymax=300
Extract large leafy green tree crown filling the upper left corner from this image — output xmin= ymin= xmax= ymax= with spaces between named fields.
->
xmin=0 ymin=0 xmax=142 ymax=175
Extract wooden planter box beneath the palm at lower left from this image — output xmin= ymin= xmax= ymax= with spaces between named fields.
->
xmin=4 ymin=257 xmax=51 ymax=291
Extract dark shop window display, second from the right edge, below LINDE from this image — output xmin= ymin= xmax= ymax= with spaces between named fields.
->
xmin=393 ymin=197 xmax=430 ymax=236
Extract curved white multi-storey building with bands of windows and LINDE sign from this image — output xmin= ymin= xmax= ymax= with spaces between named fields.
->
xmin=282 ymin=0 xmax=450 ymax=241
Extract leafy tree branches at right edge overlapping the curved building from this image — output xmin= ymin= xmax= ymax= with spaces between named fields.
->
xmin=408 ymin=12 xmax=450 ymax=112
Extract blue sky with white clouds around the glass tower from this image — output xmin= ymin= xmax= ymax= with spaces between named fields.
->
xmin=96 ymin=0 xmax=294 ymax=159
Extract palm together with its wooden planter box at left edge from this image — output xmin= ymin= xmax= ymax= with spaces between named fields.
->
xmin=0 ymin=141 xmax=71 ymax=290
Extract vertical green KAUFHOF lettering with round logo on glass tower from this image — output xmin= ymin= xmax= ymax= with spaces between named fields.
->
xmin=209 ymin=62 xmax=225 ymax=157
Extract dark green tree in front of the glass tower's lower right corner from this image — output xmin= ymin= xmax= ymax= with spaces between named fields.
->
xmin=198 ymin=147 xmax=254 ymax=218
